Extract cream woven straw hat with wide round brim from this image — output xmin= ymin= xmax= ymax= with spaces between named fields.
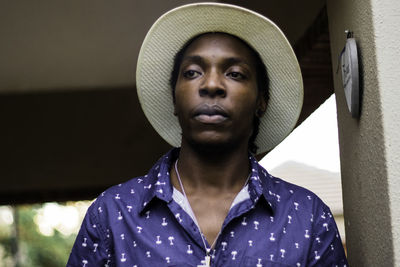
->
xmin=136 ymin=3 xmax=303 ymax=154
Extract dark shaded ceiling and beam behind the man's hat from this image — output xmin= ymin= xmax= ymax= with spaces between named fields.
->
xmin=0 ymin=1 xmax=333 ymax=204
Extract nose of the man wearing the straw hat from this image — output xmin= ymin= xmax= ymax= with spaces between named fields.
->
xmin=199 ymin=71 xmax=226 ymax=97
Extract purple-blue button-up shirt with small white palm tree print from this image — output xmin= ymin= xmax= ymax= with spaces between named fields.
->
xmin=67 ymin=149 xmax=347 ymax=267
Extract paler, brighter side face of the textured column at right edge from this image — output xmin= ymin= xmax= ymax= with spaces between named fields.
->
xmin=372 ymin=0 xmax=400 ymax=266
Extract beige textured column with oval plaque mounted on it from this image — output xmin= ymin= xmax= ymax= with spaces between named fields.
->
xmin=327 ymin=0 xmax=400 ymax=266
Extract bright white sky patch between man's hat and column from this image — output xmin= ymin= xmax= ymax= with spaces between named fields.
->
xmin=260 ymin=95 xmax=340 ymax=172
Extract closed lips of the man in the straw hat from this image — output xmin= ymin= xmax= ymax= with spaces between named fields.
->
xmin=194 ymin=104 xmax=228 ymax=124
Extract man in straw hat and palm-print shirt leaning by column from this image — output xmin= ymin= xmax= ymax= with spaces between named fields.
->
xmin=68 ymin=3 xmax=347 ymax=267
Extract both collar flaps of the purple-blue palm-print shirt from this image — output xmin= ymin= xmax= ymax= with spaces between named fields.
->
xmin=138 ymin=148 xmax=277 ymax=213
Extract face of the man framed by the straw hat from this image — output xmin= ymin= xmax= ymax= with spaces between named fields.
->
xmin=175 ymin=33 xmax=260 ymax=152
